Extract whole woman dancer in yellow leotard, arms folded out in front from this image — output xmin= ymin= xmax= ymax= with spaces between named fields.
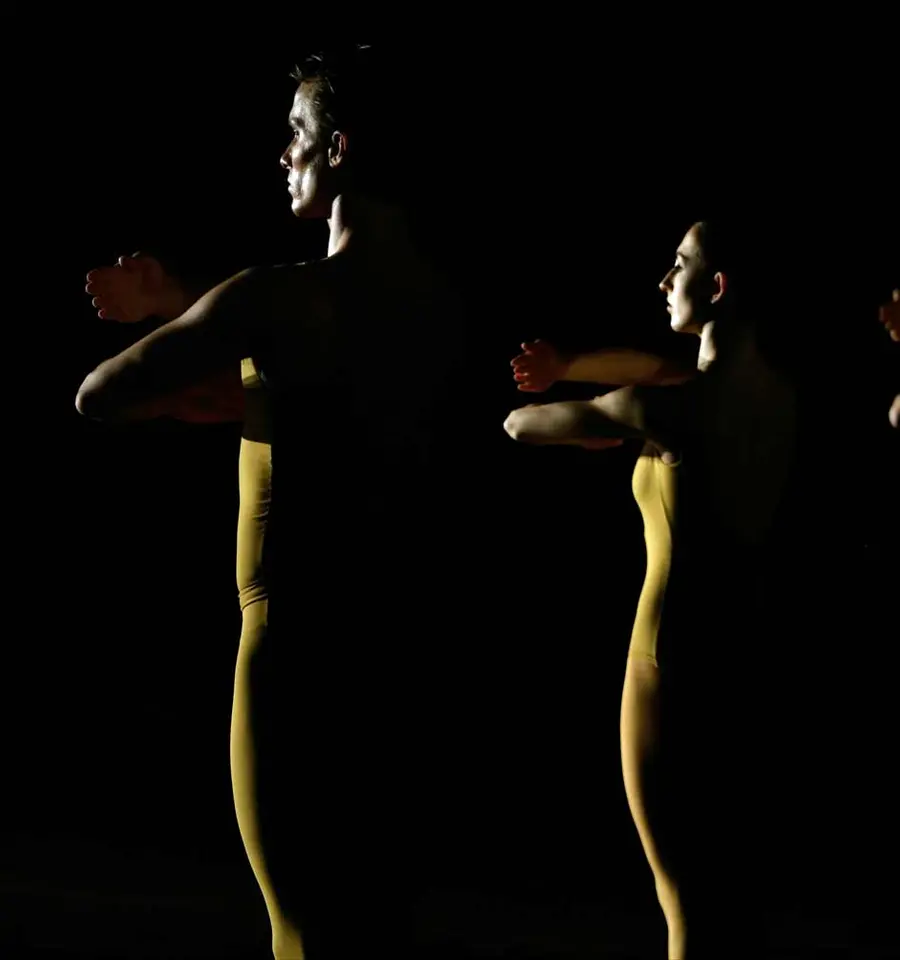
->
xmin=505 ymin=222 xmax=796 ymax=960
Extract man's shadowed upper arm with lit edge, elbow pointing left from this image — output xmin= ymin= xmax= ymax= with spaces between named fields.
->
xmin=76 ymin=269 xmax=270 ymax=418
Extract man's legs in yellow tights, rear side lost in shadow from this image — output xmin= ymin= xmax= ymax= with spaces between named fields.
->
xmin=231 ymin=601 xmax=414 ymax=960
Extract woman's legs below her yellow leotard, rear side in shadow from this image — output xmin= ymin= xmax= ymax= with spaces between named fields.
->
xmin=620 ymin=658 xmax=764 ymax=960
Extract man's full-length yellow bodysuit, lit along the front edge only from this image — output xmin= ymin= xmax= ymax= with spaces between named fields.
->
xmin=231 ymin=256 xmax=465 ymax=960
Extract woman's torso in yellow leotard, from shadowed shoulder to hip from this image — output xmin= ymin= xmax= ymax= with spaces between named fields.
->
xmin=630 ymin=350 xmax=796 ymax=676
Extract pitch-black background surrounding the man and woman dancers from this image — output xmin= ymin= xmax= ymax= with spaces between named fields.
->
xmin=7 ymin=15 xmax=900 ymax=957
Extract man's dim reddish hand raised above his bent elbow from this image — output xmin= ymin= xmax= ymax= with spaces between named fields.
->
xmin=84 ymin=253 xmax=190 ymax=323
